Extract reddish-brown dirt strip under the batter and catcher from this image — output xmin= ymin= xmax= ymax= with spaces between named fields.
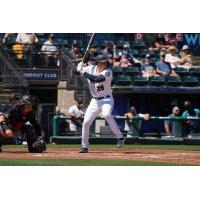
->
xmin=0 ymin=148 xmax=200 ymax=165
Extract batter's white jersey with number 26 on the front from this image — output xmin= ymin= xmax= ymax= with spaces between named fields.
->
xmin=83 ymin=65 xmax=112 ymax=97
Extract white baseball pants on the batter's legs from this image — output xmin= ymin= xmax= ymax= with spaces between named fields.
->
xmin=82 ymin=97 xmax=123 ymax=148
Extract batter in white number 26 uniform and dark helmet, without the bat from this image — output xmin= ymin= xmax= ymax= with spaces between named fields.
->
xmin=77 ymin=54 xmax=125 ymax=153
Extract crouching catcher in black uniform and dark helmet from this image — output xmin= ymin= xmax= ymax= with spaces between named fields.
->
xmin=0 ymin=95 xmax=46 ymax=153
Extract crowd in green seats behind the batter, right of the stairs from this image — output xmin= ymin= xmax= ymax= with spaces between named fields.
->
xmin=66 ymin=34 xmax=196 ymax=82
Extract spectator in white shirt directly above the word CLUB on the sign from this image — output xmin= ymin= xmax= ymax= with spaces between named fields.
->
xmin=41 ymin=34 xmax=59 ymax=67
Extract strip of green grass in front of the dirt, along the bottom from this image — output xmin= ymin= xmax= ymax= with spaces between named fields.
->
xmin=0 ymin=159 xmax=189 ymax=166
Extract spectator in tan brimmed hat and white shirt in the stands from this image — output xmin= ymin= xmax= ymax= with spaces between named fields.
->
xmin=165 ymin=46 xmax=181 ymax=69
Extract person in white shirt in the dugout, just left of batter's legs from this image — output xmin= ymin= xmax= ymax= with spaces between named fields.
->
xmin=68 ymin=98 xmax=85 ymax=132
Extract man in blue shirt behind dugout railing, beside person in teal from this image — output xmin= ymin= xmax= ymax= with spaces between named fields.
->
xmin=164 ymin=106 xmax=181 ymax=137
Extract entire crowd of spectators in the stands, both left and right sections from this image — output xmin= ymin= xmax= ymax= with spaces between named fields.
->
xmin=1 ymin=33 xmax=198 ymax=78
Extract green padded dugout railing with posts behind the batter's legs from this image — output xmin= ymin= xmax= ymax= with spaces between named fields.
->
xmin=53 ymin=114 xmax=200 ymax=137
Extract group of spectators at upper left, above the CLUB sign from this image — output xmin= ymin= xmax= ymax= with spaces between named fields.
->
xmin=0 ymin=33 xmax=59 ymax=68
